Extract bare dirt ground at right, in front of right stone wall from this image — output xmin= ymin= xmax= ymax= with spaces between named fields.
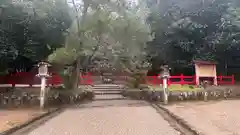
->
xmin=166 ymin=100 xmax=240 ymax=135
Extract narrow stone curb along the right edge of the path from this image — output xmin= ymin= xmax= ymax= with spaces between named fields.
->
xmin=154 ymin=104 xmax=203 ymax=135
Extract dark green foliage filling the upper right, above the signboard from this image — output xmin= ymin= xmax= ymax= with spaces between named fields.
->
xmin=147 ymin=0 xmax=240 ymax=70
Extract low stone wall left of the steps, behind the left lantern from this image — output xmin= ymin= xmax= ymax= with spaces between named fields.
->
xmin=0 ymin=87 xmax=94 ymax=108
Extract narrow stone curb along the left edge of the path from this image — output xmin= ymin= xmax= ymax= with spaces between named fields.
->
xmin=0 ymin=108 xmax=62 ymax=135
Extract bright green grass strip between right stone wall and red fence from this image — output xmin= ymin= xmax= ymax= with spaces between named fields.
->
xmin=148 ymin=84 xmax=201 ymax=91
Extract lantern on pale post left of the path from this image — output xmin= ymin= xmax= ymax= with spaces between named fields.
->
xmin=37 ymin=62 xmax=51 ymax=109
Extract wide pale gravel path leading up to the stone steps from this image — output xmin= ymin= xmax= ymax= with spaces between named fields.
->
xmin=28 ymin=100 xmax=179 ymax=135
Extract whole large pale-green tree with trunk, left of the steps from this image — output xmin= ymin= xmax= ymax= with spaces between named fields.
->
xmin=49 ymin=0 xmax=150 ymax=89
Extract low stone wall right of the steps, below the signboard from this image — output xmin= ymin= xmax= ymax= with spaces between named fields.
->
xmin=122 ymin=89 xmax=236 ymax=102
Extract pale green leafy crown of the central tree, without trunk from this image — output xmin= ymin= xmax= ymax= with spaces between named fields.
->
xmin=50 ymin=1 xmax=151 ymax=71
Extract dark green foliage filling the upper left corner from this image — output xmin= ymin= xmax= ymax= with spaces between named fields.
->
xmin=0 ymin=0 xmax=71 ymax=70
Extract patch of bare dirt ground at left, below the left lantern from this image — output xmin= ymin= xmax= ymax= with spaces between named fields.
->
xmin=0 ymin=109 xmax=46 ymax=133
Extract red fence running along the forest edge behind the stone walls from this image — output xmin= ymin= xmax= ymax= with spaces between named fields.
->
xmin=0 ymin=72 xmax=235 ymax=86
